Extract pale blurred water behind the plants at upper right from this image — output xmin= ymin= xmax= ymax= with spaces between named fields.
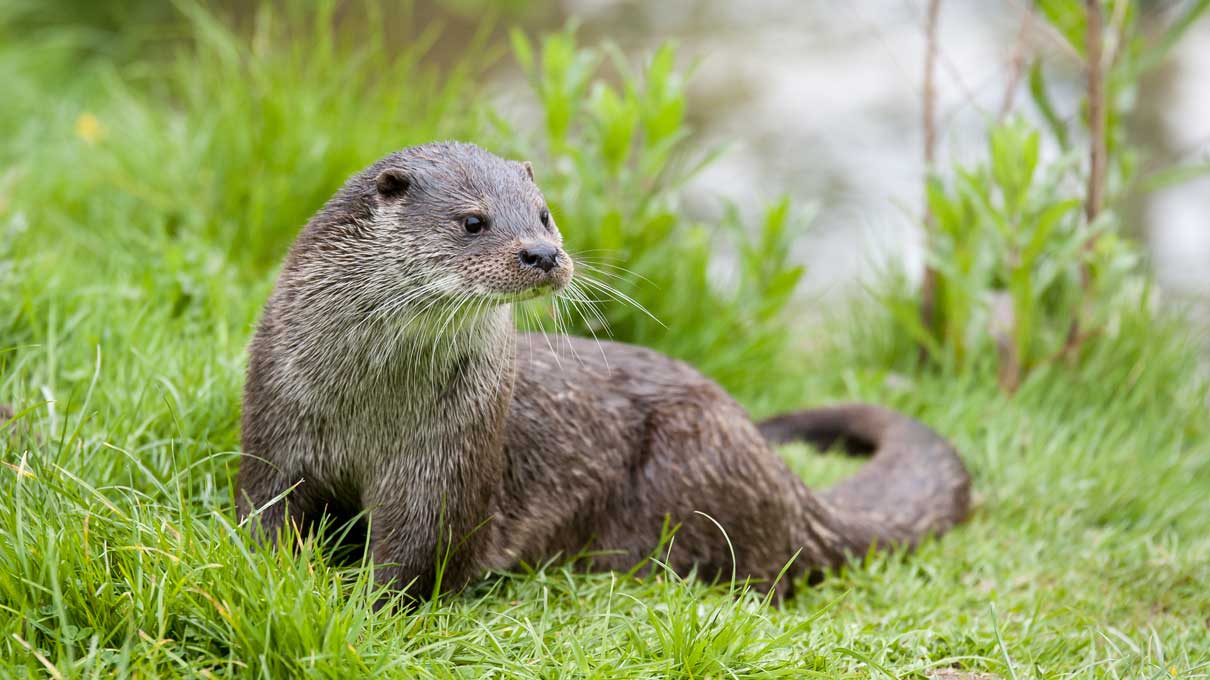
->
xmin=563 ymin=0 xmax=1210 ymax=309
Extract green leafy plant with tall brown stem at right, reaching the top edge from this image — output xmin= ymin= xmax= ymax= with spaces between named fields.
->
xmin=905 ymin=0 xmax=1210 ymax=391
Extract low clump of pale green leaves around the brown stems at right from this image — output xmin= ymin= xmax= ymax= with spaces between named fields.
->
xmin=887 ymin=119 xmax=1137 ymax=388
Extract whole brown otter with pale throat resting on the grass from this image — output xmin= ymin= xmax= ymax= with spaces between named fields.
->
xmin=236 ymin=143 xmax=970 ymax=599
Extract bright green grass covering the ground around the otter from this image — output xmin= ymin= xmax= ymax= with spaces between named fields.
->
xmin=0 ymin=2 xmax=1210 ymax=678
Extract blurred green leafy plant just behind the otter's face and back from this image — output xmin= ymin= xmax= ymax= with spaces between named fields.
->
xmin=500 ymin=29 xmax=802 ymax=394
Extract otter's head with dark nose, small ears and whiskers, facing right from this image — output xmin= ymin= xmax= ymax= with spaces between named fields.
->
xmin=363 ymin=143 xmax=574 ymax=309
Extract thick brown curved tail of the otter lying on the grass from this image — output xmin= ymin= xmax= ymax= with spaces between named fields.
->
xmin=757 ymin=404 xmax=970 ymax=559
